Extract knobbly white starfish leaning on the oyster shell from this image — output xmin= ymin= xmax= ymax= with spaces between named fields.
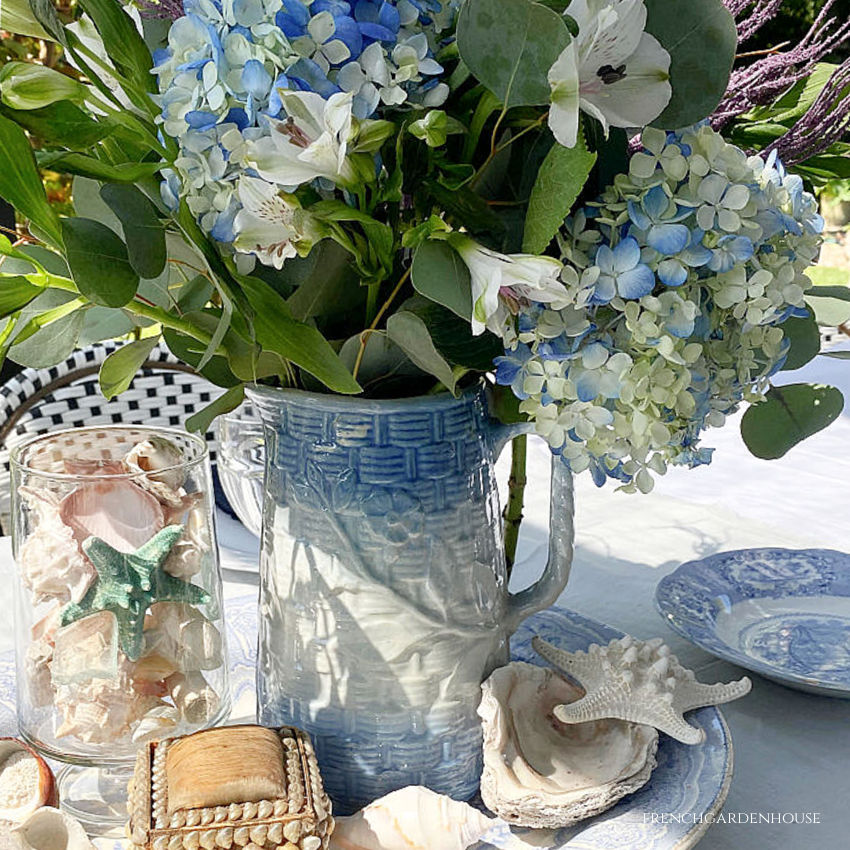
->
xmin=531 ymin=635 xmax=752 ymax=744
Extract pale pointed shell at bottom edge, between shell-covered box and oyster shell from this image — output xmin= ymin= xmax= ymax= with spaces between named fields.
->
xmin=330 ymin=785 xmax=496 ymax=850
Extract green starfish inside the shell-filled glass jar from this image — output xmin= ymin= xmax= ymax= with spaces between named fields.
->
xmin=59 ymin=525 xmax=210 ymax=661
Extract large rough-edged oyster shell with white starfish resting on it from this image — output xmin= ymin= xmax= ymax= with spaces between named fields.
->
xmin=478 ymin=662 xmax=658 ymax=828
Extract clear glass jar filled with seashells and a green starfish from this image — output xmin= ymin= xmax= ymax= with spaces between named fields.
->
xmin=11 ymin=425 xmax=230 ymax=826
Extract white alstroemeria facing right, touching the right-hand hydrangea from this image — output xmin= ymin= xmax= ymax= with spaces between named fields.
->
xmin=450 ymin=233 xmax=569 ymax=337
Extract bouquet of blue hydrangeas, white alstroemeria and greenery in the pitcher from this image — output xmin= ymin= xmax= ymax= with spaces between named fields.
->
xmin=0 ymin=0 xmax=847 ymax=491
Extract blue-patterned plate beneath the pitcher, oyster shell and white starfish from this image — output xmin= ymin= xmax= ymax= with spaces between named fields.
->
xmin=0 ymin=596 xmax=732 ymax=850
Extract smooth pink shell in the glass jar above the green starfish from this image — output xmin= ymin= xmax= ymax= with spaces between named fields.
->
xmin=59 ymin=479 xmax=165 ymax=552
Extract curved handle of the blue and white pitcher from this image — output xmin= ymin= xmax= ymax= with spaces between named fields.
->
xmin=484 ymin=414 xmax=575 ymax=634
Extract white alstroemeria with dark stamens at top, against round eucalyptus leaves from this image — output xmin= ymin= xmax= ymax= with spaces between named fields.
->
xmin=549 ymin=0 xmax=673 ymax=148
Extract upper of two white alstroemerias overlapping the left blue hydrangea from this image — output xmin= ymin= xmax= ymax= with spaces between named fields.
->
xmin=244 ymin=89 xmax=355 ymax=187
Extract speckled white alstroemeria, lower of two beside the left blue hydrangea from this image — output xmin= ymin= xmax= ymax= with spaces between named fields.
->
xmin=233 ymin=177 xmax=303 ymax=269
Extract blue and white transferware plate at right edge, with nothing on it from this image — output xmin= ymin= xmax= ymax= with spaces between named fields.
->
xmin=655 ymin=549 xmax=850 ymax=699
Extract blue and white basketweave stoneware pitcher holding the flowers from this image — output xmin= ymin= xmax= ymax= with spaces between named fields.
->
xmin=248 ymin=386 xmax=573 ymax=814
